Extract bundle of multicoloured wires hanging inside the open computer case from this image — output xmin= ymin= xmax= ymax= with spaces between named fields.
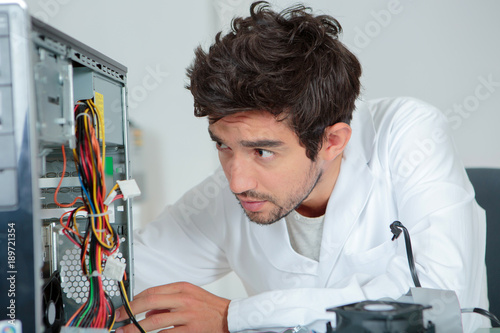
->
xmin=54 ymin=100 xmax=144 ymax=331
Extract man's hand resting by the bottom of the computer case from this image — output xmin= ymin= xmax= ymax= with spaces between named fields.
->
xmin=116 ymin=282 xmax=230 ymax=333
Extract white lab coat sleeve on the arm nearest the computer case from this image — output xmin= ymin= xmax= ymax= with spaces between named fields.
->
xmin=134 ymin=170 xmax=231 ymax=293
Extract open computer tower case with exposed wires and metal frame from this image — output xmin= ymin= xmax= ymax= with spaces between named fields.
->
xmin=0 ymin=0 xmax=133 ymax=333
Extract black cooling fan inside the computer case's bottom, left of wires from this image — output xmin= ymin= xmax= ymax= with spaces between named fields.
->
xmin=43 ymin=271 xmax=65 ymax=333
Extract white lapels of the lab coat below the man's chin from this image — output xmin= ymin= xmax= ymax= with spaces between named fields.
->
xmin=250 ymin=104 xmax=375 ymax=276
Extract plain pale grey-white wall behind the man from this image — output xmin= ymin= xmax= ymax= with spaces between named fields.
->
xmin=28 ymin=0 xmax=500 ymax=297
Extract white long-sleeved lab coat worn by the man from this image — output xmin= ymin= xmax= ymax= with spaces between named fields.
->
xmin=134 ymin=98 xmax=488 ymax=332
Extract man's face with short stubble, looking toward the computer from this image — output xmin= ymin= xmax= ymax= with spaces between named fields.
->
xmin=209 ymin=111 xmax=322 ymax=224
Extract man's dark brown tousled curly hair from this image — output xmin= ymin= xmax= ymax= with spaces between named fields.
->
xmin=186 ymin=1 xmax=361 ymax=161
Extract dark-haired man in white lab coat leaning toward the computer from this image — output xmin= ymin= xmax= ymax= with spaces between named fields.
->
xmin=117 ymin=2 xmax=488 ymax=333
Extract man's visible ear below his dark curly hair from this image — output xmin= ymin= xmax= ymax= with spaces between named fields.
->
xmin=319 ymin=123 xmax=352 ymax=161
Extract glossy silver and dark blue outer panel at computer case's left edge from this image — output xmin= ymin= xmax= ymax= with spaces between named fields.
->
xmin=0 ymin=1 xmax=42 ymax=332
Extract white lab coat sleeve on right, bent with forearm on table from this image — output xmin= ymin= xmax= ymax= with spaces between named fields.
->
xmin=229 ymin=100 xmax=487 ymax=332
